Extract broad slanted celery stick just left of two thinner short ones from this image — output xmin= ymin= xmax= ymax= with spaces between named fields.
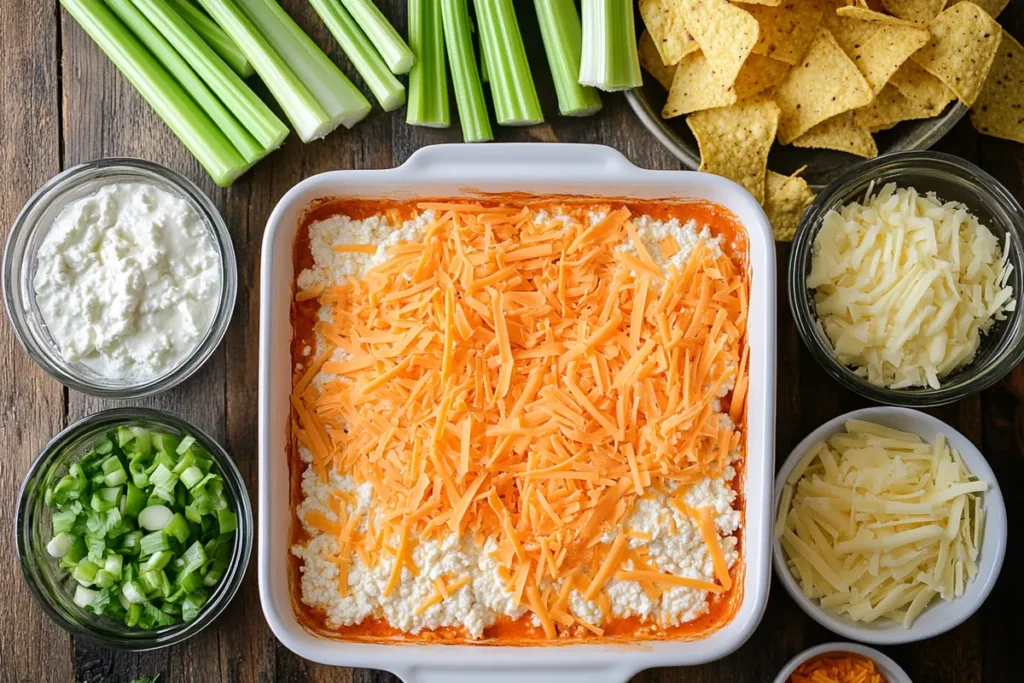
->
xmin=237 ymin=0 xmax=370 ymax=128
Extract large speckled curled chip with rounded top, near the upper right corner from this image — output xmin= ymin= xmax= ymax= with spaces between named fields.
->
xmin=910 ymin=2 xmax=1002 ymax=106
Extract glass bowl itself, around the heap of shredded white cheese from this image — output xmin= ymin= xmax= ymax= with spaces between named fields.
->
xmin=787 ymin=152 xmax=1024 ymax=408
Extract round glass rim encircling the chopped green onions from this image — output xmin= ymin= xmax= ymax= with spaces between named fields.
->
xmin=13 ymin=408 xmax=255 ymax=651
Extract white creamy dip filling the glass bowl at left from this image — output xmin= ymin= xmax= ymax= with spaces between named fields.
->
xmin=33 ymin=182 xmax=222 ymax=380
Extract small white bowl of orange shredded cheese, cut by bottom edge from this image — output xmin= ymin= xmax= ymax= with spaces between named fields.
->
xmin=775 ymin=643 xmax=910 ymax=683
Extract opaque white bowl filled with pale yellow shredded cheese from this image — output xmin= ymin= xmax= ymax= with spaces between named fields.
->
xmin=773 ymin=407 xmax=1007 ymax=644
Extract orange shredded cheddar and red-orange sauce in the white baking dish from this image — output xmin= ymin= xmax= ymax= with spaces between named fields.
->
xmin=290 ymin=196 xmax=749 ymax=644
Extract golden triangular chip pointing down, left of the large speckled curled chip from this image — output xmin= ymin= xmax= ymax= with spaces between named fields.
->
xmin=822 ymin=7 xmax=930 ymax=93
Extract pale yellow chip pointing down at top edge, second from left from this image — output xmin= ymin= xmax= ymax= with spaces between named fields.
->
xmin=676 ymin=0 xmax=758 ymax=87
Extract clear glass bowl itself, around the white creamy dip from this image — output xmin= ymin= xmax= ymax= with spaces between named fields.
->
xmin=3 ymin=158 xmax=238 ymax=399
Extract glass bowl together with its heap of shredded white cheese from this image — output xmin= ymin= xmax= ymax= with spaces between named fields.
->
xmin=788 ymin=152 xmax=1024 ymax=408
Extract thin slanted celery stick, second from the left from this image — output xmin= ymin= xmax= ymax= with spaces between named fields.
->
xmin=105 ymin=0 xmax=269 ymax=164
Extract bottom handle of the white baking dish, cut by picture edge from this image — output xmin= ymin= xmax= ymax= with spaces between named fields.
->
xmin=395 ymin=666 xmax=635 ymax=683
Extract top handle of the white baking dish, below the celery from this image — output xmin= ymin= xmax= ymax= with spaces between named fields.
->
xmin=400 ymin=142 xmax=636 ymax=180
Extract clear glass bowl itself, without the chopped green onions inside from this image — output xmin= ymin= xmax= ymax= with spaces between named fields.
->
xmin=14 ymin=408 xmax=253 ymax=650
